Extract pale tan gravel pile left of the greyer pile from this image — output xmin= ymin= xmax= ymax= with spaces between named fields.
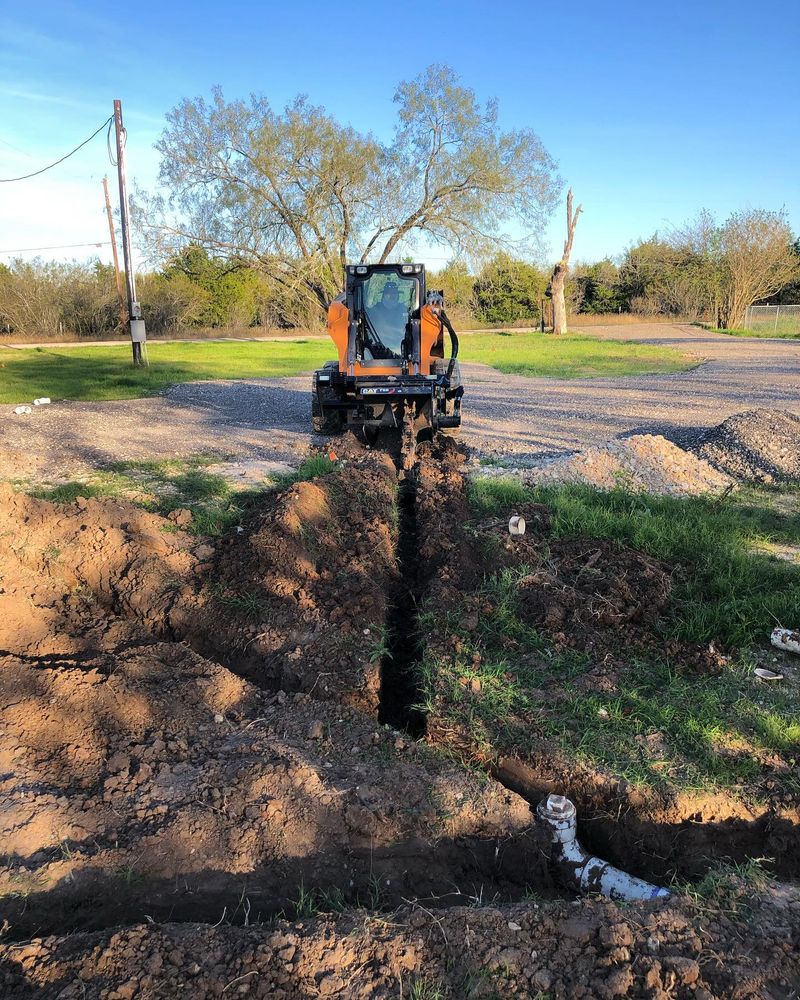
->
xmin=521 ymin=434 xmax=731 ymax=496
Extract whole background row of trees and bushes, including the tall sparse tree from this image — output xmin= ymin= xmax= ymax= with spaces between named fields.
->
xmin=0 ymin=65 xmax=800 ymax=336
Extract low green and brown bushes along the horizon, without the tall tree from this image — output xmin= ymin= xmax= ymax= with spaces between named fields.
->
xmin=0 ymin=210 xmax=800 ymax=337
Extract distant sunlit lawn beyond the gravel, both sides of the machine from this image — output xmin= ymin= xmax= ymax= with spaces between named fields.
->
xmin=0 ymin=333 xmax=694 ymax=403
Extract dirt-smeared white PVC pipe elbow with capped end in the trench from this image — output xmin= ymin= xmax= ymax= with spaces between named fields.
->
xmin=536 ymin=795 xmax=670 ymax=899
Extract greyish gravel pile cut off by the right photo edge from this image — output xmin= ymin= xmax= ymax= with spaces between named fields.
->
xmin=692 ymin=409 xmax=800 ymax=483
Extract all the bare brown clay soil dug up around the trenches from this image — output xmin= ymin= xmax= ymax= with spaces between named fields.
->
xmin=0 ymin=441 xmax=800 ymax=1000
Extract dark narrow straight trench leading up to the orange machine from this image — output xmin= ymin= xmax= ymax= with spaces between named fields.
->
xmin=378 ymin=474 xmax=426 ymax=739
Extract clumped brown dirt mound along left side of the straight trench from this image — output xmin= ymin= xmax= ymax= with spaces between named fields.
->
xmin=188 ymin=454 xmax=397 ymax=710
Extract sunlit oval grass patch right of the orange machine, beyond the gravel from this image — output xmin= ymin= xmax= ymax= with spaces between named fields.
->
xmin=459 ymin=333 xmax=697 ymax=378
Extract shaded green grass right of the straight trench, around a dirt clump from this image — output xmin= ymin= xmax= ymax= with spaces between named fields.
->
xmin=422 ymin=480 xmax=800 ymax=800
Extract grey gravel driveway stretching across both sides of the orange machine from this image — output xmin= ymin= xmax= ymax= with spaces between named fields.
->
xmin=0 ymin=324 xmax=800 ymax=478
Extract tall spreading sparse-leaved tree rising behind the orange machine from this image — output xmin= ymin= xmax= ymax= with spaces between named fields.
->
xmin=137 ymin=66 xmax=559 ymax=320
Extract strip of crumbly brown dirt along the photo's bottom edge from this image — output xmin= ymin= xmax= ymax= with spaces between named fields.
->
xmin=0 ymin=885 xmax=800 ymax=1000
